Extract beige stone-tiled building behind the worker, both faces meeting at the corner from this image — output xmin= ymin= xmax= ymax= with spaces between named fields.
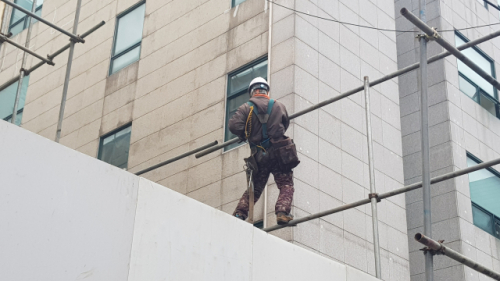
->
xmin=0 ymin=0 xmax=410 ymax=281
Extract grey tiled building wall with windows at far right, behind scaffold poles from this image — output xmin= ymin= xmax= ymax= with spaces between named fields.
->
xmin=396 ymin=0 xmax=500 ymax=280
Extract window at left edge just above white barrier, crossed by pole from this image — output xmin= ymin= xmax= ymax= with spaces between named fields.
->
xmin=0 ymin=76 xmax=29 ymax=126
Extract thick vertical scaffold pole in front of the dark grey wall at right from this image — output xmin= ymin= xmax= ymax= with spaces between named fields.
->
xmin=419 ymin=0 xmax=434 ymax=281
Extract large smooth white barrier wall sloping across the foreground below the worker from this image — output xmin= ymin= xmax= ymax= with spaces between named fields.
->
xmin=0 ymin=121 xmax=377 ymax=281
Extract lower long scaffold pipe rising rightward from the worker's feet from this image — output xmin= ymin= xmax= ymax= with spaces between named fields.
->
xmin=263 ymin=158 xmax=500 ymax=232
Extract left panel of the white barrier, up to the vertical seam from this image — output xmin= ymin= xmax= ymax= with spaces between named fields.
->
xmin=0 ymin=121 xmax=139 ymax=280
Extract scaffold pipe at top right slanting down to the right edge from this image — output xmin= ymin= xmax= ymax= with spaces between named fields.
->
xmin=401 ymin=8 xmax=500 ymax=90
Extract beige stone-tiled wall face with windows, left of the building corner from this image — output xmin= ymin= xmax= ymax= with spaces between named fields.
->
xmin=0 ymin=0 xmax=269 ymax=217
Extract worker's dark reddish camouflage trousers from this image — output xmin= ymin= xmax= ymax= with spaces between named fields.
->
xmin=234 ymin=151 xmax=294 ymax=218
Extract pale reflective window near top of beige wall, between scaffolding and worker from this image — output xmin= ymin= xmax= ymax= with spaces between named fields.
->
xmin=109 ymin=2 xmax=146 ymax=75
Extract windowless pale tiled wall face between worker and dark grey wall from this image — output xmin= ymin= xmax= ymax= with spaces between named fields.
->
xmin=269 ymin=1 xmax=409 ymax=280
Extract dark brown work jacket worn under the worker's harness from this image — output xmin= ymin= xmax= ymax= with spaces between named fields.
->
xmin=229 ymin=95 xmax=290 ymax=144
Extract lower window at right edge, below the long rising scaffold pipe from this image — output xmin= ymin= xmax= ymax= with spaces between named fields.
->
xmin=467 ymin=153 xmax=500 ymax=238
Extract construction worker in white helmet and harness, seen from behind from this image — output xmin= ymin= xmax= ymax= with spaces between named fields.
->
xmin=229 ymin=77 xmax=300 ymax=224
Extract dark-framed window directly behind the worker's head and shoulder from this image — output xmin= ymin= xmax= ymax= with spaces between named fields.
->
xmin=224 ymin=58 xmax=267 ymax=151
